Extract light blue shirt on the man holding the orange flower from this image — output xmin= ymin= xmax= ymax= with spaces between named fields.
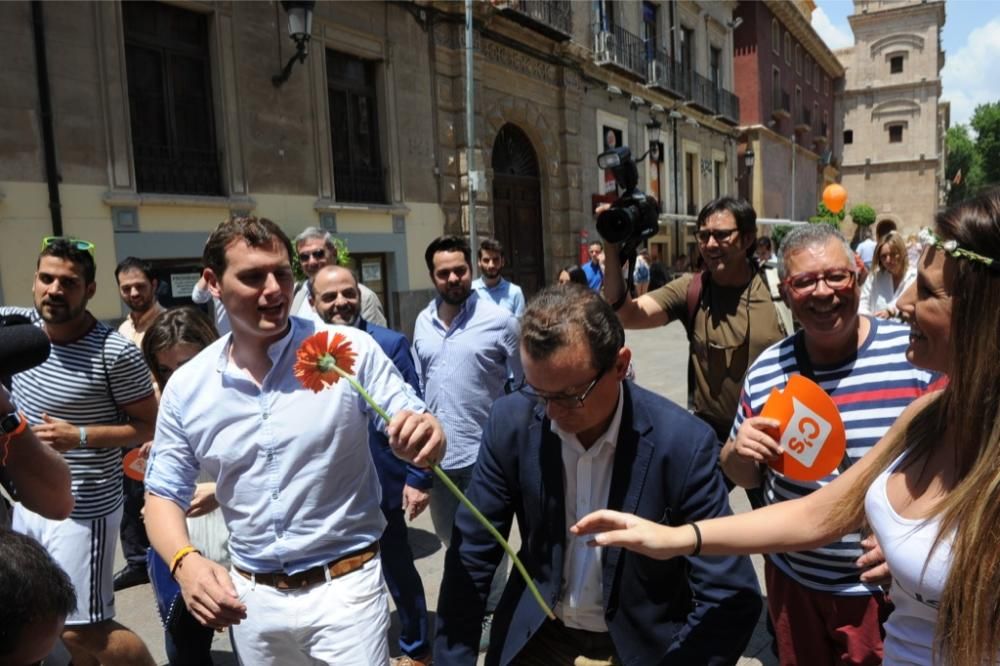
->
xmin=146 ymin=317 xmax=426 ymax=574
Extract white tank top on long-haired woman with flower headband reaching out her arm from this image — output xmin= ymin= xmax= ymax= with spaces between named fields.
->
xmin=865 ymin=453 xmax=951 ymax=666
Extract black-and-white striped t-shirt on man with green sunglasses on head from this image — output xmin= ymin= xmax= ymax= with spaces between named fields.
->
xmin=0 ymin=307 xmax=153 ymax=519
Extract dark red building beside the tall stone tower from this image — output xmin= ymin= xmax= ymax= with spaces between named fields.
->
xmin=734 ymin=0 xmax=844 ymax=220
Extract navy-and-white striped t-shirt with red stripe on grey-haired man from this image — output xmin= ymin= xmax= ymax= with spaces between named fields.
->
xmin=730 ymin=318 xmax=944 ymax=594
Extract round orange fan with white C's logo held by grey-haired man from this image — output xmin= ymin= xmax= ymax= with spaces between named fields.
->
xmin=760 ymin=375 xmax=847 ymax=481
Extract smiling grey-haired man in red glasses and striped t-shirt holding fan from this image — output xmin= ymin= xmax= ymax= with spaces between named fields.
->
xmin=721 ymin=224 xmax=936 ymax=665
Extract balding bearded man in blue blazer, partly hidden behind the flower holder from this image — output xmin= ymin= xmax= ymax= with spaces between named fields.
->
xmin=310 ymin=266 xmax=433 ymax=666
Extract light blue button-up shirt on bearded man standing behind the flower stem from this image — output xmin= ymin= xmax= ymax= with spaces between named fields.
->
xmin=413 ymin=291 xmax=524 ymax=469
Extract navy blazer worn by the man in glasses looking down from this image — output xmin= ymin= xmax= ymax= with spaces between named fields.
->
xmin=434 ymin=382 xmax=761 ymax=666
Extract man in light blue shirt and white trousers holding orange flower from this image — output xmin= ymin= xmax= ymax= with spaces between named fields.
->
xmin=146 ymin=217 xmax=444 ymax=666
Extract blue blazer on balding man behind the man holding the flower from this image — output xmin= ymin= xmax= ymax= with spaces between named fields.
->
xmin=357 ymin=319 xmax=434 ymax=512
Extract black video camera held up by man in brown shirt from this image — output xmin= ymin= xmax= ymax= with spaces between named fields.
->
xmin=597 ymin=146 xmax=660 ymax=258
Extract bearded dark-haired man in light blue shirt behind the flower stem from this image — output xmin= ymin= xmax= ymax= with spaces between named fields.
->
xmin=413 ymin=236 xmax=522 ymax=648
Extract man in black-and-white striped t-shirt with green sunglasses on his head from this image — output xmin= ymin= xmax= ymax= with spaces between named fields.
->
xmin=0 ymin=237 xmax=156 ymax=665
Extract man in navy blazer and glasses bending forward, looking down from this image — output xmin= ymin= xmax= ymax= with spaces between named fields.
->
xmin=434 ymin=284 xmax=761 ymax=666
